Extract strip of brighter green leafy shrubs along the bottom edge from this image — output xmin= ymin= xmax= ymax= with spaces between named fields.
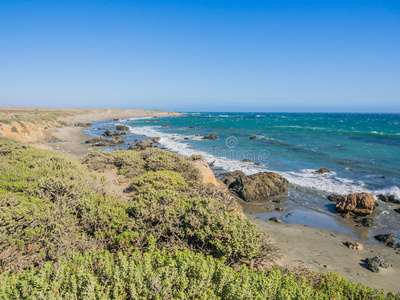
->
xmin=0 ymin=246 xmax=399 ymax=300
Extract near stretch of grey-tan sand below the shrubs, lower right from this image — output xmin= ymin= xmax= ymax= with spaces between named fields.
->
xmin=245 ymin=213 xmax=400 ymax=292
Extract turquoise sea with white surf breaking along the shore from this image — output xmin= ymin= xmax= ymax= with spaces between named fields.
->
xmin=87 ymin=113 xmax=400 ymax=239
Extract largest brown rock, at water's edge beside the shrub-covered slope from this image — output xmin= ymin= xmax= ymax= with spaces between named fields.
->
xmin=229 ymin=172 xmax=289 ymax=202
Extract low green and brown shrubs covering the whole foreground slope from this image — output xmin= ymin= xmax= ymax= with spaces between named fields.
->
xmin=0 ymin=137 xmax=400 ymax=299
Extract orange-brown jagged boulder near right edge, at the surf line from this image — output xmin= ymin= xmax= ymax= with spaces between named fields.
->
xmin=335 ymin=193 xmax=375 ymax=216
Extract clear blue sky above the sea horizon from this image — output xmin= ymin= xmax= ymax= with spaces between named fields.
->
xmin=0 ymin=0 xmax=400 ymax=112
